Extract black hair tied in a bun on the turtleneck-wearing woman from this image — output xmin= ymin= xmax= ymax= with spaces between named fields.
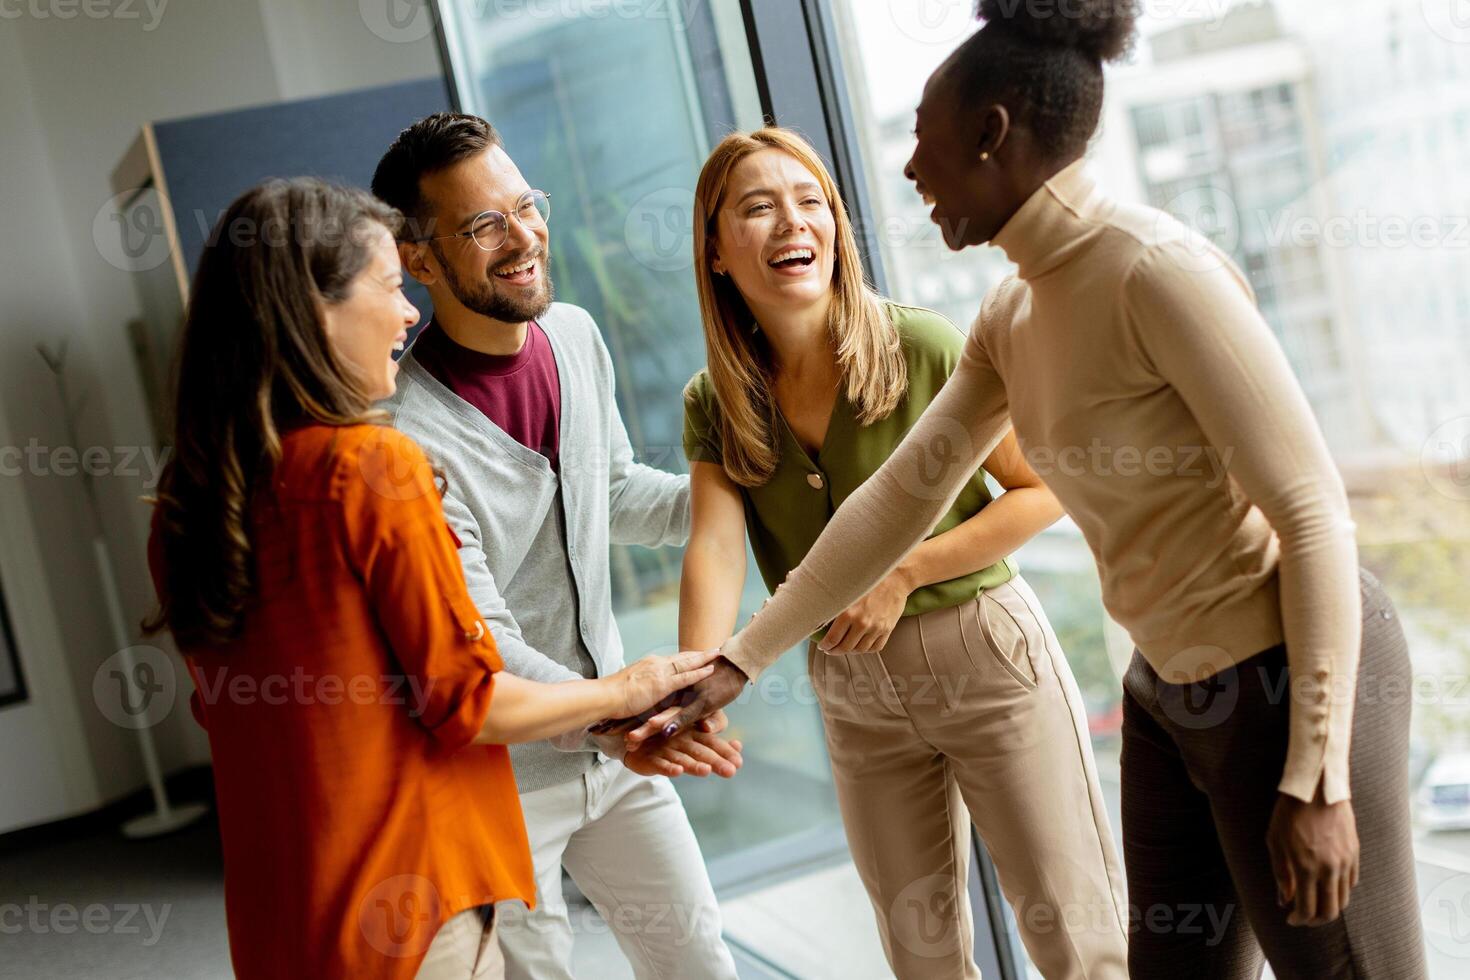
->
xmin=951 ymin=0 xmax=1139 ymax=160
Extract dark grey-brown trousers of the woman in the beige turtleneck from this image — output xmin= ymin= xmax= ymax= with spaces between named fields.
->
xmin=1123 ymin=572 xmax=1426 ymax=980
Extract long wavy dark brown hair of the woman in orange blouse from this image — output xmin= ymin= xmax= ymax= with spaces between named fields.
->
xmin=144 ymin=178 xmax=403 ymax=646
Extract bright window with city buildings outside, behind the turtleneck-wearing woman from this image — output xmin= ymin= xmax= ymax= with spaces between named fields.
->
xmin=835 ymin=0 xmax=1470 ymax=979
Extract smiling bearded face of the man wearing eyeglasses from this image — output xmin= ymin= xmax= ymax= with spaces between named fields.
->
xmin=404 ymin=145 xmax=553 ymax=323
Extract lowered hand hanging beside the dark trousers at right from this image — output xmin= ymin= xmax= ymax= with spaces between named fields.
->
xmin=1266 ymin=789 xmax=1358 ymax=926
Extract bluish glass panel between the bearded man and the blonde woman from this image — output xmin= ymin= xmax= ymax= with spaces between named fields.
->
xmin=432 ymin=0 xmax=842 ymax=867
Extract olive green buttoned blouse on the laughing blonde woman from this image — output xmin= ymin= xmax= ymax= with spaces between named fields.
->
xmin=684 ymin=303 xmax=1017 ymax=628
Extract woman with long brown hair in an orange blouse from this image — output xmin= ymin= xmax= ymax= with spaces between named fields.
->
xmin=148 ymin=179 xmax=738 ymax=980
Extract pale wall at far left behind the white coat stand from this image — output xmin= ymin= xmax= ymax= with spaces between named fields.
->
xmin=0 ymin=0 xmax=438 ymax=830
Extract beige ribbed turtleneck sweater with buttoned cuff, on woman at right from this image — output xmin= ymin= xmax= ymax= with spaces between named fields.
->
xmin=722 ymin=160 xmax=1361 ymax=802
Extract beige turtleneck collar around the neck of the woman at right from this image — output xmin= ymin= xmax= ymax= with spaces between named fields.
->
xmin=991 ymin=157 xmax=1105 ymax=279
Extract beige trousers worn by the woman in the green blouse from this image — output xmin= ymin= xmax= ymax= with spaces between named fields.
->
xmin=807 ymin=577 xmax=1127 ymax=980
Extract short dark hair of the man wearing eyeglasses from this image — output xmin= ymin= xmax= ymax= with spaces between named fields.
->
xmin=372 ymin=112 xmax=503 ymax=238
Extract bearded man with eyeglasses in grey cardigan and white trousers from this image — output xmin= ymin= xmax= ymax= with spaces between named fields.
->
xmin=372 ymin=113 xmax=739 ymax=980
